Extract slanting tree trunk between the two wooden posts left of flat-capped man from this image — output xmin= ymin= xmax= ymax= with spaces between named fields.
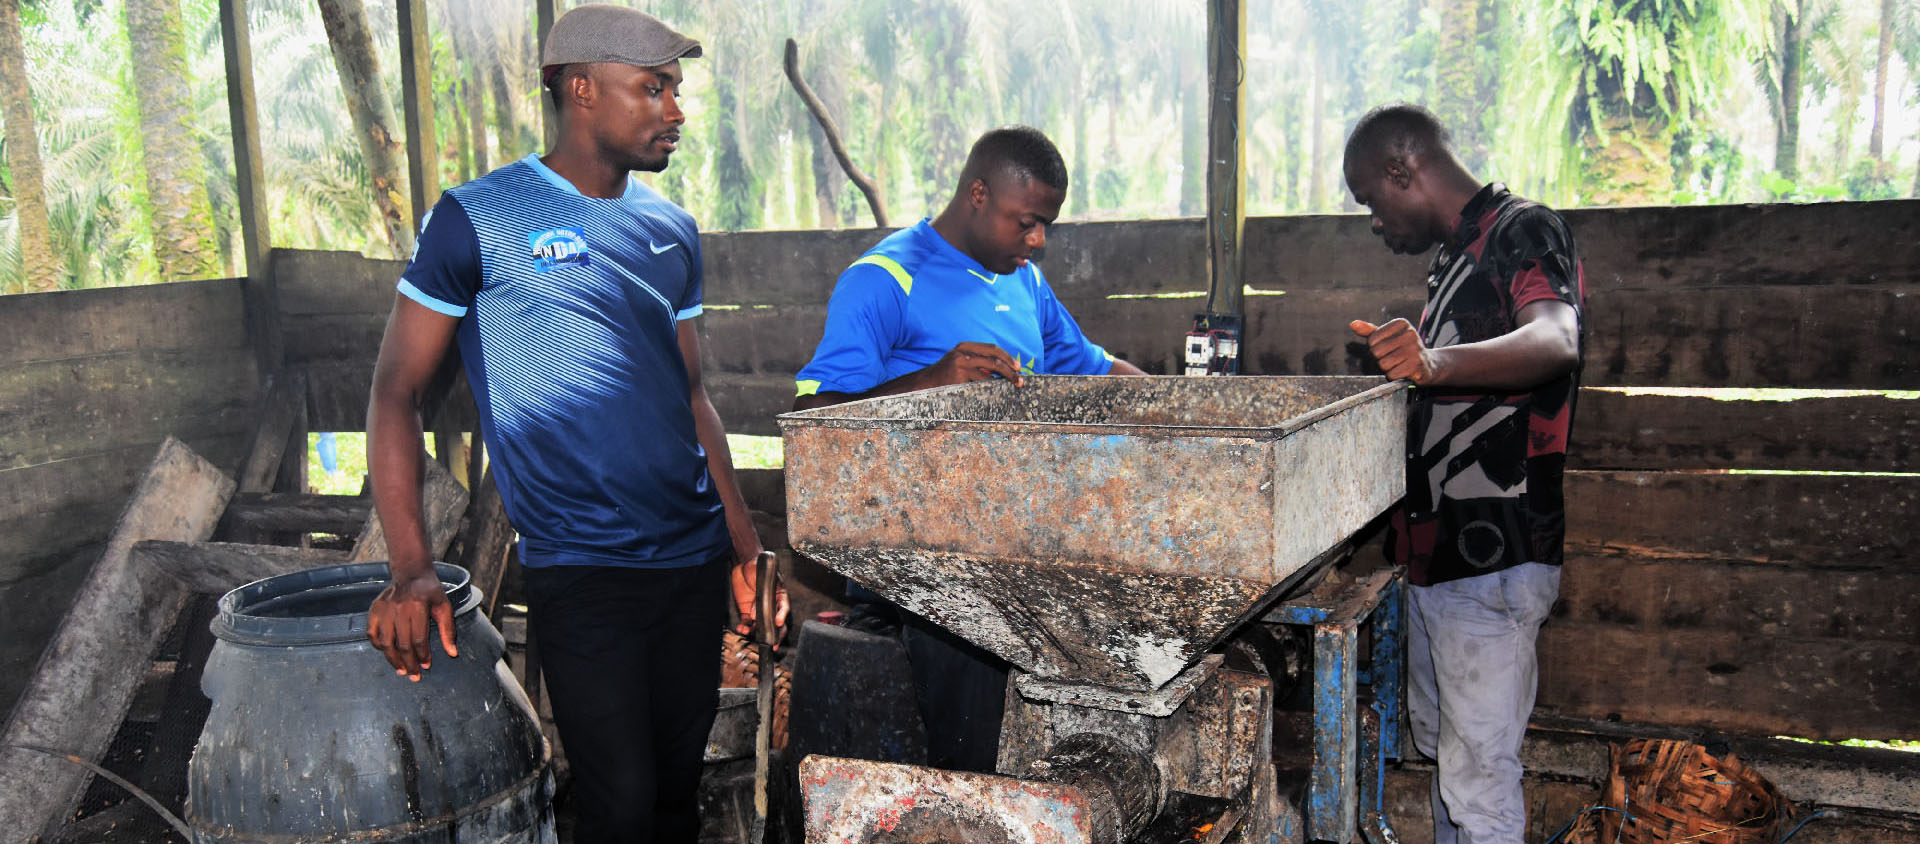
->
xmin=319 ymin=0 xmax=413 ymax=257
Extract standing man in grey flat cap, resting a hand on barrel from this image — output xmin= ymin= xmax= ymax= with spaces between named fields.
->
xmin=367 ymin=4 xmax=785 ymax=842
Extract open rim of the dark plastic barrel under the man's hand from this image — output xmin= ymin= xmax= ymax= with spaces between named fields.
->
xmin=209 ymin=562 xmax=480 ymax=646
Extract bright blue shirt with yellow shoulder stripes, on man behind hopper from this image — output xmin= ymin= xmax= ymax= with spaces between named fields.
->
xmin=795 ymin=221 xmax=1114 ymax=395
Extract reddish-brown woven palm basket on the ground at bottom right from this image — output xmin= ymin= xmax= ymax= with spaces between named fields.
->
xmin=1567 ymin=739 xmax=1793 ymax=844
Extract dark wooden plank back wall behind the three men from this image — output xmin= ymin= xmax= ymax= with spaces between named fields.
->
xmin=275 ymin=199 xmax=1920 ymax=739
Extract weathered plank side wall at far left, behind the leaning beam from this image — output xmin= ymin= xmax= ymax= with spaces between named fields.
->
xmin=0 ymin=280 xmax=257 ymax=712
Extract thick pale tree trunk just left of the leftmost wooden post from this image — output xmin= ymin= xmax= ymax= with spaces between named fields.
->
xmin=127 ymin=0 xmax=219 ymax=280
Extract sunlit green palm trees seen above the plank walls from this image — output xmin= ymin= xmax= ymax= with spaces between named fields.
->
xmin=0 ymin=0 xmax=1920 ymax=292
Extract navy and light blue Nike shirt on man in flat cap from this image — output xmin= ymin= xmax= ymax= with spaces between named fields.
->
xmin=399 ymin=155 xmax=728 ymax=568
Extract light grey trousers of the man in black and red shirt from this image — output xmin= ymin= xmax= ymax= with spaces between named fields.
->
xmin=1407 ymin=562 xmax=1561 ymax=844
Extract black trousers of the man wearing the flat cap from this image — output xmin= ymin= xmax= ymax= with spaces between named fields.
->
xmin=526 ymin=554 xmax=732 ymax=844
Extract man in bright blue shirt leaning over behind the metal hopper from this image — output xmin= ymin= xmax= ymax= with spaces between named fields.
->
xmin=793 ymin=127 xmax=1146 ymax=771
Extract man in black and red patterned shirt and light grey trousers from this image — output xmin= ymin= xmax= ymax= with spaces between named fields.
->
xmin=1346 ymin=106 xmax=1586 ymax=844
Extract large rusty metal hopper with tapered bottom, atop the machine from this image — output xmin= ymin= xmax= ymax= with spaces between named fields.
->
xmin=780 ymin=376 xmax=1407 ymax=692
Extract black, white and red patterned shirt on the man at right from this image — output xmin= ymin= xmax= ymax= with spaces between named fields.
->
xmin=1386 ymin=184 xmax=1586 ymax=585
